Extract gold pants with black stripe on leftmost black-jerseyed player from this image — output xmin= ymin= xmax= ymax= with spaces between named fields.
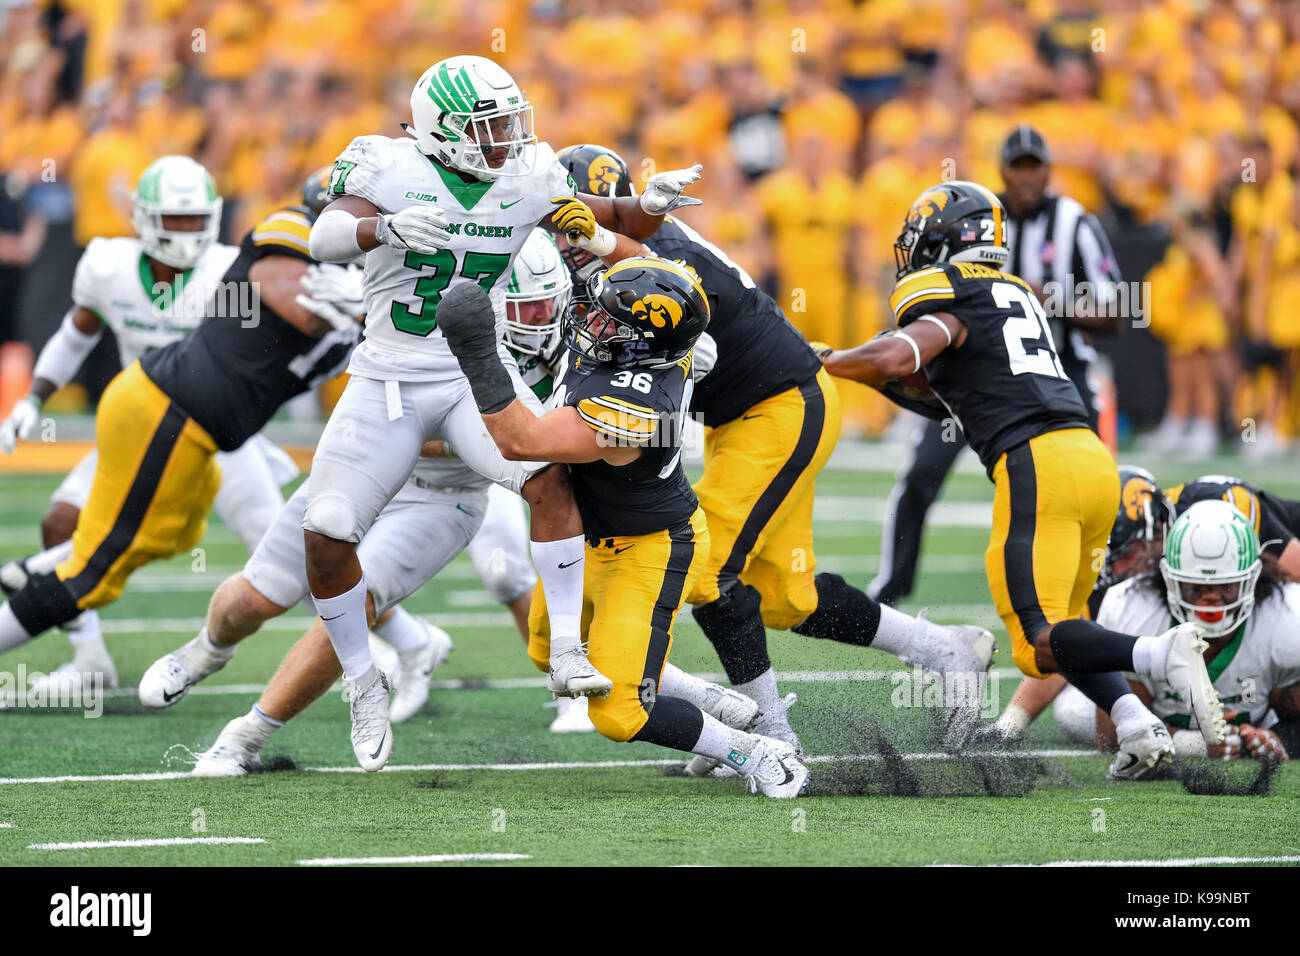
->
xmin=55 ymin=362 xmax=221 ymax=610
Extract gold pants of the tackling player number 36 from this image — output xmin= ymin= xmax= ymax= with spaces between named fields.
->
xmin=528 ymin=509 xmax=709 ymax=740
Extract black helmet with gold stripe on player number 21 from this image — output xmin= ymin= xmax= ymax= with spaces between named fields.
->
xmin=894 ymin=179 xmax=1011 ymax=278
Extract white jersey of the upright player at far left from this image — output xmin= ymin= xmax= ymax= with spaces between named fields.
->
xmin=73 ymin=237 xmax=239 ymax=368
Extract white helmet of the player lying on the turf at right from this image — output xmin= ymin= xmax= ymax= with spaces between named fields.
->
xmin=1160 ymin=501 xmax=1264 ymax=637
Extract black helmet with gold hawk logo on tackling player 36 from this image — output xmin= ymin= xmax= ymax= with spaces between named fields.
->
xmin=566 ymin=256 xmax=709 ymax=368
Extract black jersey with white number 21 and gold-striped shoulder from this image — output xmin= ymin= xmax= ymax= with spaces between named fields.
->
xmin=889 ymin=263 xmax=1088 ymax=477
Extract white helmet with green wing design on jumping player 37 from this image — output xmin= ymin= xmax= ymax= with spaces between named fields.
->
xmin=406 ymin=56 xmax=537 ymax=181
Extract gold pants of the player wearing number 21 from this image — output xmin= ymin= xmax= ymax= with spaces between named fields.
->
xmin=984 ymin=428 xmax=1119 ymax=678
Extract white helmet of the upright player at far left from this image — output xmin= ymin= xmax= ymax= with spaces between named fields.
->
xmin=131 ymin=156 xmax=221 ymax=269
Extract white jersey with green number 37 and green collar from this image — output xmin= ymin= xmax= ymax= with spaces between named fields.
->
xmin=329 ymin=137 xmax=576 ymax=381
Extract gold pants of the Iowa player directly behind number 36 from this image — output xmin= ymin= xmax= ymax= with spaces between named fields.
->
xmin=686 ymin=371 xmax=840 ymax=631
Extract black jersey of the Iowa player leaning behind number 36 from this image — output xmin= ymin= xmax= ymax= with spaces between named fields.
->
xmin=645 ymin=216 xmax=822 ymax=427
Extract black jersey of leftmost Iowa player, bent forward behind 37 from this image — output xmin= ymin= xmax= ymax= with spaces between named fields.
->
xmin=140 ymin=206 xmax=361 ymax=451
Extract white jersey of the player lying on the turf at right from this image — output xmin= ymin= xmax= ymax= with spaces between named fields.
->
xmin=1097 ymin=580 xmax=1300 ymax=727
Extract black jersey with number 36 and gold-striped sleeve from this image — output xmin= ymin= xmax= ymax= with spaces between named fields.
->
xmin=555 ymin=355 xmax=699 ymax=540
